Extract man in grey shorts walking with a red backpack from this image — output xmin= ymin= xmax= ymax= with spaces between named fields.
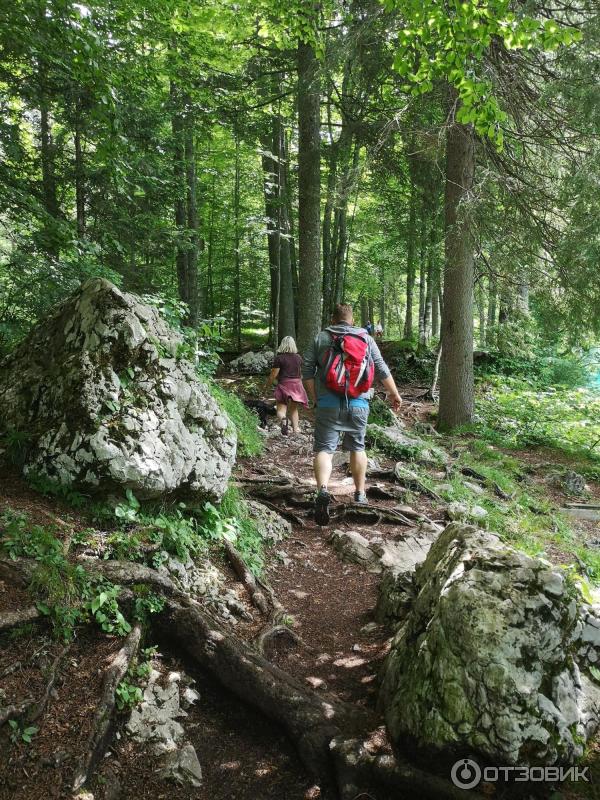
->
xmin=302 ymin=303 xmax=402 ymax=525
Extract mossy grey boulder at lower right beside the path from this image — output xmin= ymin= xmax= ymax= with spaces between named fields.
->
xmin=380 ymin=522 xmax=600 ymax=765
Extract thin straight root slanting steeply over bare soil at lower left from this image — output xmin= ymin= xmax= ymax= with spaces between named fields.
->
xmin=73 ymin=625 xmax=142 ymax=792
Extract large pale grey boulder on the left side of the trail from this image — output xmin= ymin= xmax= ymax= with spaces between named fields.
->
xmin=0 ymin=278 xmax=236 ymax=499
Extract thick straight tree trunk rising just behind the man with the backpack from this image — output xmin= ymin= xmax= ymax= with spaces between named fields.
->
xmin=297 ymin=36 xmax=322 ymax=352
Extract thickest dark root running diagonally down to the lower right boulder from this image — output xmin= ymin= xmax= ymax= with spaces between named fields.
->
xmin=155 ymin=600 xmax=474 ymax=800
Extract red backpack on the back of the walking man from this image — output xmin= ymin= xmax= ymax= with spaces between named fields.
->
xmin=325 ymin=331 xmax=375 ymax=398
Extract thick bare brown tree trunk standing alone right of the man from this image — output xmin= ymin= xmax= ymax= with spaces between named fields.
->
xmin=438 ymin=99 xmax=475 ymax=430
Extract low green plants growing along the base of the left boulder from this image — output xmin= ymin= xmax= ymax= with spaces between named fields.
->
xmin=0 ymin=476 xmax=264 ymax=641
